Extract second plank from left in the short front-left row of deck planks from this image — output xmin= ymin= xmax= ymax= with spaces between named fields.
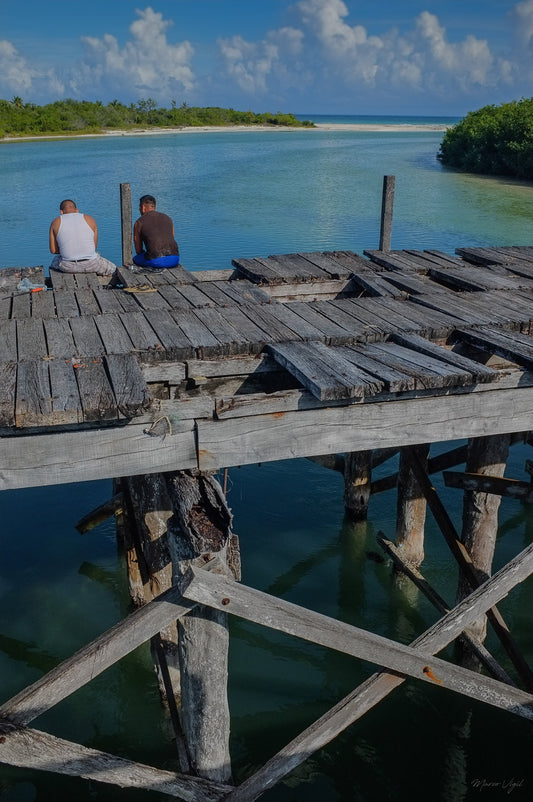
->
xmin=15 ymin=359 xmax=52 ymax=429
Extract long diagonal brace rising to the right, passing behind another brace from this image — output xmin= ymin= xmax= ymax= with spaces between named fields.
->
xmin=223 ymin=536 xmax=532 ymax=802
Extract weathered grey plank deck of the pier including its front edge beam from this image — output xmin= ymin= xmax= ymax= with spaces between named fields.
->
xmin=0 ymin=247 xmax=533 ymax=488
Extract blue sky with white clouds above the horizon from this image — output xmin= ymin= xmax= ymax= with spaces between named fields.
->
xmin=0 ymin=0 xmax=533 ymax=115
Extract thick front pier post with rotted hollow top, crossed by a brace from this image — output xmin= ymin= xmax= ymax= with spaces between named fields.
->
xmin=168 ymin=471 xmax=240 ymax=782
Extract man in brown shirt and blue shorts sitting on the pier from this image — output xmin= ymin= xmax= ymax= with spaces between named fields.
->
xmin=133 ymin=195 xmax=180 ymax=270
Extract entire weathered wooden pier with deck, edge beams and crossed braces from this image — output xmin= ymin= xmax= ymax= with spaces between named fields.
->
xmin=0 ymin=242 xmax=533 ymax=800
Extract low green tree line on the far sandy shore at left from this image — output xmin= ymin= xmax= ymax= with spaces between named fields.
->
xmin=0 ymin=97 xmax=313 ymax=136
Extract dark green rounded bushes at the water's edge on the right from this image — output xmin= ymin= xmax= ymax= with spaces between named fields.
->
xmin=437 ymin=98 xmax=533 ymax=180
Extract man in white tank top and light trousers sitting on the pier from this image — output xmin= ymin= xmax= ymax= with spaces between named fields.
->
xmin=50 ymin=200 xmax=116 ymax=276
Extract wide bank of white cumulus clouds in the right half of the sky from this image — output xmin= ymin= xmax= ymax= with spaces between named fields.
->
xmin=217 ymin=0 xmax=533 ymax=104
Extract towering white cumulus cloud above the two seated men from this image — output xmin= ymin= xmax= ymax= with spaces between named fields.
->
xmin=69 ymin=6 xmax=194 ymax=99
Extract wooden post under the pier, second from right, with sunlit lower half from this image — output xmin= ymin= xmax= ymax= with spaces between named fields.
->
xmin=396 ymin=445 xmax=429 ymax=568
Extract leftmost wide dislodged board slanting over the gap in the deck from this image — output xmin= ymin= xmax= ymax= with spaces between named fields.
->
xmin=268 ymin=342 xmax=384 ymax=400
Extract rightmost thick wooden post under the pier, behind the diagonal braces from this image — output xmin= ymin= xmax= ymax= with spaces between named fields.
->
xmin=457 ymin=434 xmax=510 ymax=652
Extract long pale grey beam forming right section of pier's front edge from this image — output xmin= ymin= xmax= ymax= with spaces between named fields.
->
xmin=198 ymin=385 xmax=533 ymax=470
